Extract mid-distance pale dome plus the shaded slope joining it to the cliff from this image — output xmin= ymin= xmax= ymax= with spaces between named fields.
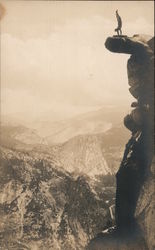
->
xmin=55 ymin=126 xmax=129 ymax=177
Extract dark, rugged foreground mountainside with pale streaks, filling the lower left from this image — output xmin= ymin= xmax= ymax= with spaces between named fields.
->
xmin=0 ymin=147 xmax=114 ymax=250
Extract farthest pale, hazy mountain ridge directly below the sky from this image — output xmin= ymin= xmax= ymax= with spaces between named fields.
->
xmin=1 ymin=107 xmax=128 ymax=145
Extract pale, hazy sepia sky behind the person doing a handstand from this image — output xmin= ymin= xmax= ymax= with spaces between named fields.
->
xmin=0 ymin=1 xmax=154 ymax=122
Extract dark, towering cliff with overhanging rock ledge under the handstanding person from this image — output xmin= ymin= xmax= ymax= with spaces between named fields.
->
xmin=88 ymin=35 xmax=155 ymax=250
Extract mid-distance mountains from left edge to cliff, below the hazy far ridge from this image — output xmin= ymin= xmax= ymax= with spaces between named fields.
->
xmin=0 ymin=119 xmax=129 ymax=177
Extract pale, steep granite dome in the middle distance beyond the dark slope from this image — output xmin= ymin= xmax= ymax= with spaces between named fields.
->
xmin=58 ymin=135 xmax=112 ymax=177
